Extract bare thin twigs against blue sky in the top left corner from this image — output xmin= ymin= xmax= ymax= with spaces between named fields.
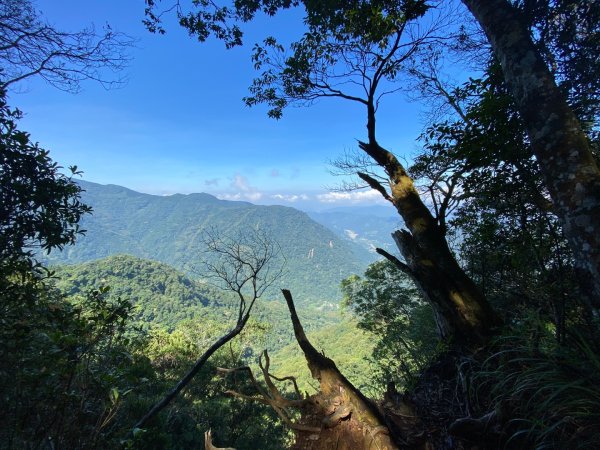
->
xmin=0 ymin=0 xmax=135 ymax=92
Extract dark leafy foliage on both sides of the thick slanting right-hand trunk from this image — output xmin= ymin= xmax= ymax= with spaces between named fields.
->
xmin=411 ymin=0 xmax=600 ymax=341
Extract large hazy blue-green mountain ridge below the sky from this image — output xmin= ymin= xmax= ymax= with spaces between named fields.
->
xmin=48 ymin=181 xmax=369 ymax=304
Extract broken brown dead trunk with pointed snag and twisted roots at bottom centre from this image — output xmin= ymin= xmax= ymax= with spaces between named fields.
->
xmin=218 ymin=289 xmax=431 ymax=450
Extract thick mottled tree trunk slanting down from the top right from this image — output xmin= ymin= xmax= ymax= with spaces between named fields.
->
xmin=462 ymin=0 xmax=600 ymax=307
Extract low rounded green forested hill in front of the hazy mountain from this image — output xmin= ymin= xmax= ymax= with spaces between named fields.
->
xmin=54 ymin=255 xmax=340 ymax=351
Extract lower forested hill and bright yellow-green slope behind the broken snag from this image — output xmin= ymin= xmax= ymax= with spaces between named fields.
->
xmin=54 ymin=255 xmax=380 ymax=391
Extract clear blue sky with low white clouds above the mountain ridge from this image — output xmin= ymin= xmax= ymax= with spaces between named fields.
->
xmin=10 ymin=0 xmax=434 ymax=206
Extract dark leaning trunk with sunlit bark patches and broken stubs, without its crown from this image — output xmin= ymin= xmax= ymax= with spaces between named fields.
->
xmin=359 ymin=139 xmax=500 ymax=346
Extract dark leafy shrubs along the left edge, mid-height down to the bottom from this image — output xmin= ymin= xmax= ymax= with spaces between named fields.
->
xmin=0 ymin=89 xmax=149 ymax=448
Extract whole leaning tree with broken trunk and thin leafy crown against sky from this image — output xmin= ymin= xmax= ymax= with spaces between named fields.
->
xmin=145 ymin=0 xmax=498 ymax=343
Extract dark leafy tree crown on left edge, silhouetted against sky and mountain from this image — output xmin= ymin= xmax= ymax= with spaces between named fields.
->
xmin=0 ymin=93 xmax=90 ymax=270
